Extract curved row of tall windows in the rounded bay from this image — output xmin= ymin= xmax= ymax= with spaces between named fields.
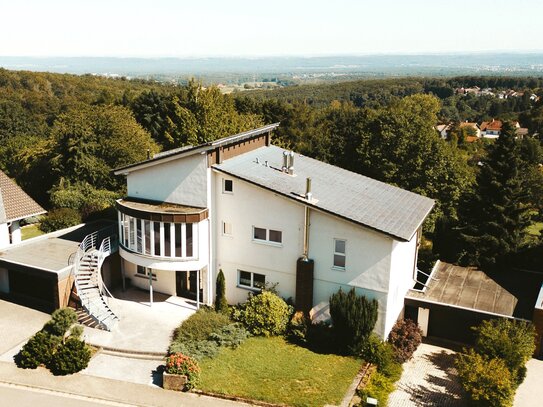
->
xmin=119 ymin=212 xmax=198 ymax=258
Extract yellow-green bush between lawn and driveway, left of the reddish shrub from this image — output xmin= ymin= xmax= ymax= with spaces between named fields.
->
xmin=360 ymin=334 xmax=402 ymax=383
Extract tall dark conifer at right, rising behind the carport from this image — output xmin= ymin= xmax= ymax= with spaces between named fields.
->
xmin=461 ymin=123 xmax=530 ymax=266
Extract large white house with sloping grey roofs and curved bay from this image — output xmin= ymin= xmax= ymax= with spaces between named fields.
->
xmin=115 ymin=124 xmax=434 ymax=337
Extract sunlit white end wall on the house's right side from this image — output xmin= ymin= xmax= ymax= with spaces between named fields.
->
xmin=384 ymin=233 xmax=417 ymax=336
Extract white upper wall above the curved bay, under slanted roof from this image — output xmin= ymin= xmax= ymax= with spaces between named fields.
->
xmin=127 ymin=154 xmax=207 ymax=208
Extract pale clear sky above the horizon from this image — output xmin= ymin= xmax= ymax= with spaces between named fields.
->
xmin=4 ymin=0 xmax=543 ymax=57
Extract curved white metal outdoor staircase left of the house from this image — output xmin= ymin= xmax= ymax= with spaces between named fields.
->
xmin=73 ymin=229 xmax=119 ymax=331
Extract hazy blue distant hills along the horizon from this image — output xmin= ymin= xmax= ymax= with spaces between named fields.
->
xmin=0 ymin=52 xmax=543 ymax=80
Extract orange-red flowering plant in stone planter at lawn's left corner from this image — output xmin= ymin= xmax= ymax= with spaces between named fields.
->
xmin=166 ymin=353 xmax=200 ymax=391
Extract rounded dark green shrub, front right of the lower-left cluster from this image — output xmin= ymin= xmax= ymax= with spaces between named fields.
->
xmin=47 ymin=337 xmax=91 ymax=375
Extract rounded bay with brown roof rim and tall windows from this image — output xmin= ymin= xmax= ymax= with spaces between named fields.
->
xmin=116 ymin=199 xmax=208 ymax=263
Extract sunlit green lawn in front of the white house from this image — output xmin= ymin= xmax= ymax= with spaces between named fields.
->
xmin=198 ymin=337 xmax=361 ymax=406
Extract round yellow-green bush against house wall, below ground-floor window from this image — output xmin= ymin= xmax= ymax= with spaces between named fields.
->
xmin=236 ymin=291 xmax=290 ymax=336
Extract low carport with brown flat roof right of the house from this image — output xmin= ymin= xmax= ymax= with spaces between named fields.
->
xmin=405 ymin=262 xmax=543 ymax=343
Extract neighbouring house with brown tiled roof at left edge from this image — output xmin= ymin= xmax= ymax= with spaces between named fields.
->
xmin=0 ymin=171 xmax=46 ymax=248
